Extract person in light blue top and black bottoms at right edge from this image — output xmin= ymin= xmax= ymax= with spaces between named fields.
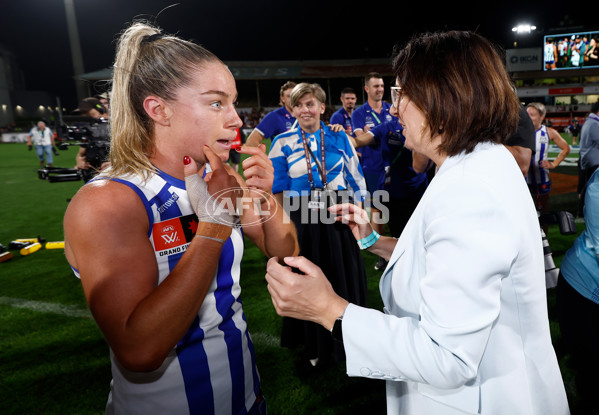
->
xmin=557 ymin=170 xmax=599 ymax=414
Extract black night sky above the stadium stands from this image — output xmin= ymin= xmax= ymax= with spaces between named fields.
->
xmin=0 ymin=0 xmax=599 ymax=109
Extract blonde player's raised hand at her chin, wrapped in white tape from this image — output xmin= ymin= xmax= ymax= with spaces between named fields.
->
xmin=183 ymin=146 xmax=243 ymax=226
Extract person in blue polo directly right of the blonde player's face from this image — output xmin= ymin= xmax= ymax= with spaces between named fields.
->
xmin=245 ymin=81 xmax=296 ymax=147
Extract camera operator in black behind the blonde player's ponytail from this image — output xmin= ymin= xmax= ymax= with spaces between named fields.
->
xmin=73 ymin=97 xmax=110 ymax=181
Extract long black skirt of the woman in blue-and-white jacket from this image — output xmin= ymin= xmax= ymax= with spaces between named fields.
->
xmin=281 ymin=200 xmax=367 ymax=361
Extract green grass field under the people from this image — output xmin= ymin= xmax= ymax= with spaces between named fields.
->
xmin=0 ymin=144 xmax=584 ymax=415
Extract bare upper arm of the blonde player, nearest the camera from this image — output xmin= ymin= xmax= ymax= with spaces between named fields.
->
xmin=65 ymin=183 xmax=158 ymax=332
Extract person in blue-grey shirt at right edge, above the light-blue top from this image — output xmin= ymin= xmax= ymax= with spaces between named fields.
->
xmin=578 ymin=101 xmax=599 ymax=216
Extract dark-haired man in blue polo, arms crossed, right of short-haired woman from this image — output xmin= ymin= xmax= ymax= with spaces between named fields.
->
xmin=352 ymin=72 xmax=392 ymax=270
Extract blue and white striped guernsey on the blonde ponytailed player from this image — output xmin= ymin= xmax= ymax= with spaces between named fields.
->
xmin=78 ymin=168 xmax=260 ymax=415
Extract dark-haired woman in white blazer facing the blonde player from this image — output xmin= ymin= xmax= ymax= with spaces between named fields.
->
xmin=266 ymin=32 xmax=569 ymax=415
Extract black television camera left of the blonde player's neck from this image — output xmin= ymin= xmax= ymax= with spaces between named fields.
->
xmin=37 ymin=116 xmax=110 ymax=183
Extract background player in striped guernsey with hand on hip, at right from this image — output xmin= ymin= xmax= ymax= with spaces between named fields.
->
xmin=526 ymin=102 xmax=570 ymax=234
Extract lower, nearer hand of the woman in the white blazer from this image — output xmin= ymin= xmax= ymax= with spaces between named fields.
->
xmin=265 ymin=257 xmax=349 ymax=330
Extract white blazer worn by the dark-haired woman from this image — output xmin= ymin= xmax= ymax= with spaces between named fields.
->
xmin=343 ymin=143 xmax=569 ymax=415
